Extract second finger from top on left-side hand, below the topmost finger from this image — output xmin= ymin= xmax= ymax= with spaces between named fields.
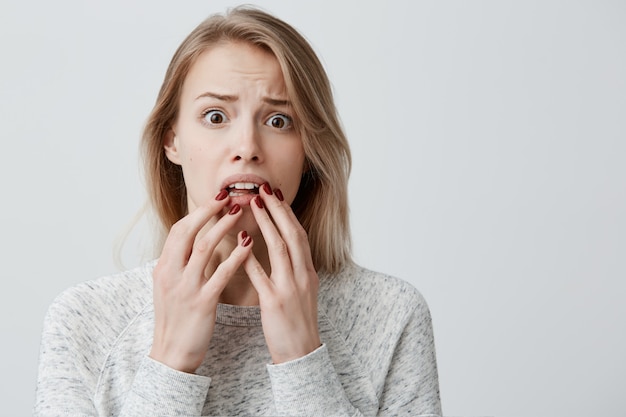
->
xmin=186 ymin=204 xmax=243 ymax=279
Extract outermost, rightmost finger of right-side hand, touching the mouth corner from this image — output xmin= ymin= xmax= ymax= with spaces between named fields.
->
xmin=259 ymin=186 xmax=314 ymax=269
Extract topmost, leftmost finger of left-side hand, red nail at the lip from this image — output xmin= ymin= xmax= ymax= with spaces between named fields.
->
xmin=160 ymin=193 xmax=229 ymax=267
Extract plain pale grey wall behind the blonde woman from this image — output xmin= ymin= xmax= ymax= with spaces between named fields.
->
xmin=0 ymin=0 xmax=626 ymax=417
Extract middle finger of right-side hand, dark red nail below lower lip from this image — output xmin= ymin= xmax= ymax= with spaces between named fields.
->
xmin=250 ymin=195 xmax=293 ymax=279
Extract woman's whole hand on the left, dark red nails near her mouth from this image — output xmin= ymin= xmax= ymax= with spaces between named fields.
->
xmin=150 ymin=192 xmax=252 ymax=373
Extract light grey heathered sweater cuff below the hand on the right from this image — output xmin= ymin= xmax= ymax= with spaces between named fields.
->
xmin=267 ymin=344 xmax=354 ymax=416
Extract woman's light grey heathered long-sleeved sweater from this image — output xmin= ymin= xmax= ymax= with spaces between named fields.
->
xmin=35 ymin=261 xmax=441 ymax=417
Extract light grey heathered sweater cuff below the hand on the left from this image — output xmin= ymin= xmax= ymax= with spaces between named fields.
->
xmin=124 ymin=356 xmax=211 ymax=416
